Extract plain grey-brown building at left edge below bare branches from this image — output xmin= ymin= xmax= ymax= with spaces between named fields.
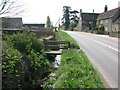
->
xmin=0 ymin=17 xmax=23 ymax=30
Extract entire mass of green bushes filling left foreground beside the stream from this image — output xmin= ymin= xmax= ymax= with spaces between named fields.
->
xmin=2 ymin=31 xmax=50 ymax=89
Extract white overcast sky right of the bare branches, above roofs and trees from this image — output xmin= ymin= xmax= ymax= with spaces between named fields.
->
xmin=23 ymin=0 xmax=120 ymax=25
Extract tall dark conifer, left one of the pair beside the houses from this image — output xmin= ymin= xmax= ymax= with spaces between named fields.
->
xmin=61 ymin=6 xmax=71 ymax=29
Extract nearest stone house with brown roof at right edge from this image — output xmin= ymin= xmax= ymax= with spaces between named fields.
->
xmin=97 ymin=5 xmax=120 ymax=32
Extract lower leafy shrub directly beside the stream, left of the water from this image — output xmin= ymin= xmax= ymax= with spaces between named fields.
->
xmin=24 ymin=49 xmax=50 ymax=88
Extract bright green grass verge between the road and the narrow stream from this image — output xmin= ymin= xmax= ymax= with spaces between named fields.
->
xmin=43 ymin=31 xmax=104 ymax=88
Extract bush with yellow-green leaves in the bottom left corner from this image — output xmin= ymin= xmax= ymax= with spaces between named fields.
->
xmin=2 ymin=41 xmax=23 ymax=88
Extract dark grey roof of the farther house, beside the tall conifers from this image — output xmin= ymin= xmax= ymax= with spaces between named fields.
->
xmin=81 ymin=13 xmax=99 ymax=21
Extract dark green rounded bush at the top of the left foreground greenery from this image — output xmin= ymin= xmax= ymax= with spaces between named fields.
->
xmin=7 ymin=32 xmax=44 ymax=53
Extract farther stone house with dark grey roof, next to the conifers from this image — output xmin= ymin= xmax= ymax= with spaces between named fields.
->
xmin=77 ymin=9 xmax=99 ymax=31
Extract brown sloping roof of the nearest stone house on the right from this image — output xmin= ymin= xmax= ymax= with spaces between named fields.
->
xmin=97 ymin=7 xmax=120 ymax=20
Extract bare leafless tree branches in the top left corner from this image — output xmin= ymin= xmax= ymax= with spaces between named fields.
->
xmin=0 ymin=0 xmax=24 ymax=16
